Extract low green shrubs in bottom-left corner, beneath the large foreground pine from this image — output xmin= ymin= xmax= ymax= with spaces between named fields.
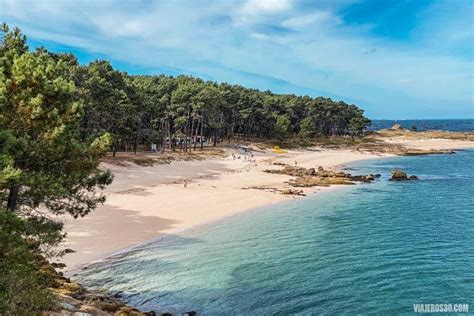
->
xmin=0 ymin=209 xmax=62 ymax=315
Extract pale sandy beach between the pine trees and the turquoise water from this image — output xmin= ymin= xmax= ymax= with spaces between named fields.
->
xmin=62 ymin=138 xmax=474 ymax=270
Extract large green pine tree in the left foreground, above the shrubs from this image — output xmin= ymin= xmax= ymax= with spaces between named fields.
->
xmin=0 ymin=27 xmax=111 ymax=217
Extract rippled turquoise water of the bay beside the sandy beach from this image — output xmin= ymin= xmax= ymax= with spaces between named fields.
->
xmin=76 ymin=151 xmax=474 ymax=315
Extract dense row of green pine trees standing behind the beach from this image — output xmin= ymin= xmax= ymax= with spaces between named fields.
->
xmin=47 ymin=49 xmax=370 ymax=152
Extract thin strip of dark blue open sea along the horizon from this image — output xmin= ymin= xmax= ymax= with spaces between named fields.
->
xmin=369 ymin=119 xmax=474 ymax=132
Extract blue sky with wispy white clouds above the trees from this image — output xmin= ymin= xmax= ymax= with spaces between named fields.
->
xmin=0 ymin=0 xmax=474 ymax=119
